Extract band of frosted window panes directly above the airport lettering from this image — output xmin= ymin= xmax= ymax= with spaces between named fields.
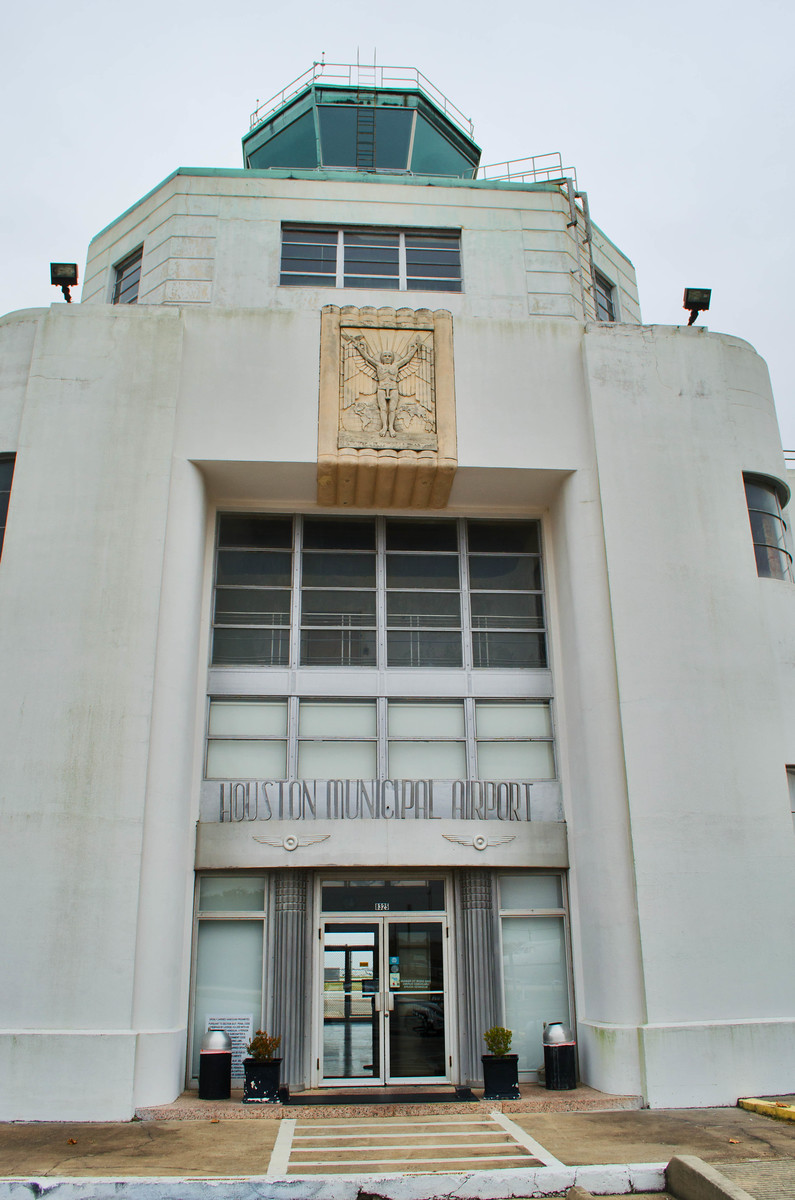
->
xmin=205 ymin=697 xmax=555 ymax=781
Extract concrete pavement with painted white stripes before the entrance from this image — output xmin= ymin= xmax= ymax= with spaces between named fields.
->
xmin=0 ymin=1104 xmax=795 ymax=1200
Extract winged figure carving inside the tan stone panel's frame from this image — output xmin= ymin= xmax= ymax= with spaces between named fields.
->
xmin=342 ymin=329 xmax=436 ymax=438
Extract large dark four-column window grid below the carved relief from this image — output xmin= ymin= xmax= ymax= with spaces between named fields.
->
xmin=213 ymin=514 xmax=546 ymax=670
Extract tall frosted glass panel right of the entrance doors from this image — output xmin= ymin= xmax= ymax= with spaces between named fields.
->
xmin=502 ymin=917 xmax=570 ymax=1070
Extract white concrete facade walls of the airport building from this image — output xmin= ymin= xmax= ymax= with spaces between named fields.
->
xmin=0 ymin=129 xmax=795 ymax=1120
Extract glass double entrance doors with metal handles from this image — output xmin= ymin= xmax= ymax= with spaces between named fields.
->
xmin=321 ymin=917 xmax=449 ymax=1086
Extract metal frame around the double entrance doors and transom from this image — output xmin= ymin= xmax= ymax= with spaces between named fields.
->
xmin=310 ymin=871 xmax=459 ymax=1088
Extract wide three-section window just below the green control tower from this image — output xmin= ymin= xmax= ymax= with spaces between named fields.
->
xmin=280 ymin=226 xmax=461 ymax=292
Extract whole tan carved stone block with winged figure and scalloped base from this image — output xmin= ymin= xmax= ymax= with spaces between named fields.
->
xmin=317 ymin=305 xmax=458 ymax=508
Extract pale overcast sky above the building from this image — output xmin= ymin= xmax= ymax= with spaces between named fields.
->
xmin=0 ymin=0 xmax=795 ymax=449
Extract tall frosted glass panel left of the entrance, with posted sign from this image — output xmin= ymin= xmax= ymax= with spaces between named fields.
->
xmin=192 ymin=920 xmax=263 ymax=1086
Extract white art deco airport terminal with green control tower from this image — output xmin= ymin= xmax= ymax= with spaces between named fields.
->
xmin=0 ymin=67 xmax=795 ymax=1120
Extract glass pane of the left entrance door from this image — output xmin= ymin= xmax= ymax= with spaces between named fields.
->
xmin=323 ymin=924 xmax=381 ymax=1079
